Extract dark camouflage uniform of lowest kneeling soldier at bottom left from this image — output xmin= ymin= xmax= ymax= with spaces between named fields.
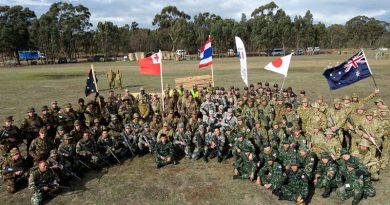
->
xmin=28 ymin=168 xmax=59 ymax=205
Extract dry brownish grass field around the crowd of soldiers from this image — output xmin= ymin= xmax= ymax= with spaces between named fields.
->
xmin=0 ymin=54 xmax=390 ymax=204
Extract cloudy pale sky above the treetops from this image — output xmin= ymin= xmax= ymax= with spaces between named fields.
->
xmin=0 ymin=0 xmax=390 ymax=28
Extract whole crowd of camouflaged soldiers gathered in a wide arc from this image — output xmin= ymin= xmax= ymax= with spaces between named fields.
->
xmin=0 ymin=82 xmax=390 ymax=204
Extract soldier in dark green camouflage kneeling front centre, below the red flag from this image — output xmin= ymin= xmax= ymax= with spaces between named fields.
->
xmin=155 ymin=134 xmax=175 ymax=169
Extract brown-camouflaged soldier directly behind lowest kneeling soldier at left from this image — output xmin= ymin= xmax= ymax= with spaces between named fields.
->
xmin=28 ymin=128 xmax=53 ymax=165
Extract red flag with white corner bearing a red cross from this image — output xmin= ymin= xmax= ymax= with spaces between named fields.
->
xmin=138 ymin=52 xmax=161 ymax=75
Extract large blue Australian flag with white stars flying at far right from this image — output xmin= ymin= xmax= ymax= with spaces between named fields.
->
xmin=322 ymin=50 xmax=372 ymax=90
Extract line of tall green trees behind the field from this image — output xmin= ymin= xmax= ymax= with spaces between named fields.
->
xmin=0 ymin=2 xmax=390 ymax=63
